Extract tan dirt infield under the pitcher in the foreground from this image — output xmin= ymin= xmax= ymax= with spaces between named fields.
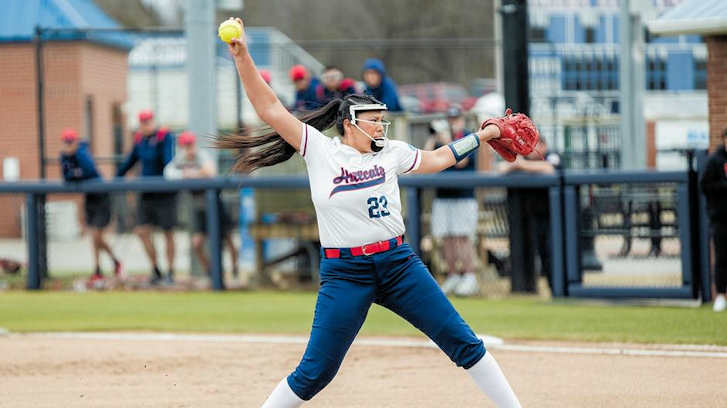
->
xmin=0 ymin=336 xmax=727 ymax=408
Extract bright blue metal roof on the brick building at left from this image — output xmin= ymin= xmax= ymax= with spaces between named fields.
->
xmin=0 ymin=0 xmax=133 ymax=49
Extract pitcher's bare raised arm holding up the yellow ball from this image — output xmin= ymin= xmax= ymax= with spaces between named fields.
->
xmin=227 ymin=18 xmax=302 ymax=150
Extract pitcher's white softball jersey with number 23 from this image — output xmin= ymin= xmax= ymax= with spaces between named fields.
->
xmin=298 ymin=125 xmax=422 ymax=248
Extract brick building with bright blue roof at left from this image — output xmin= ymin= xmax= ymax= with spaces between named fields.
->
xmin=0 ymin=0 xmax=131 ymax=237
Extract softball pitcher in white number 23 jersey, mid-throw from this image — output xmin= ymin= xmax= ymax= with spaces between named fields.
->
xmin=218 ymin=19 xmax=536 ymax=408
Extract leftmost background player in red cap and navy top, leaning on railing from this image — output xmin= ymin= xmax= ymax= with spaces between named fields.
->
xmin=61 ymin=129 xmax=121 ymax=286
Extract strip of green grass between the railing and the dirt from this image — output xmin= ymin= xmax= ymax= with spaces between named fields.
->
xmin=0 ymin=291 xmax=727 ymax=345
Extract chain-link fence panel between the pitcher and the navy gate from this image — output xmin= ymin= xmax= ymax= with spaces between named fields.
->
xmin=421 ymin=176 xmax=561 ymax=298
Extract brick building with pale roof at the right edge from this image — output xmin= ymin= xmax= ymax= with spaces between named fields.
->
xmin=649 ymin=0 xmax=727 ymax=149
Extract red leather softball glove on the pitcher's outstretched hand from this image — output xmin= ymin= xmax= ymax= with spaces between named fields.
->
xmin=480 ymin=109 xmax=540 ymax=162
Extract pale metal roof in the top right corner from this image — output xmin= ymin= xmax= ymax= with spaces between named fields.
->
xmin=647 ymin=0 xmax=727 ymax=36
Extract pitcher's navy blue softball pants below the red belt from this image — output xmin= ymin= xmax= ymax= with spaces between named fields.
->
xmin=288 ymin=244 xmax=485 ymax=400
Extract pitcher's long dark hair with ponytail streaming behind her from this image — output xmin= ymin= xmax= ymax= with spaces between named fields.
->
xmin=214 ymin=99 xmax=343 ymax=174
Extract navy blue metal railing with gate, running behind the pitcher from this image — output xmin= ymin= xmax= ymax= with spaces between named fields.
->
xmin=0 ymin=159 xmax=710 ymax=300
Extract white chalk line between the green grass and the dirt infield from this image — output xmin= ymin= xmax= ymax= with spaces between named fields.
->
xmin=6 ymin=332 xmax=727 ymax=358
